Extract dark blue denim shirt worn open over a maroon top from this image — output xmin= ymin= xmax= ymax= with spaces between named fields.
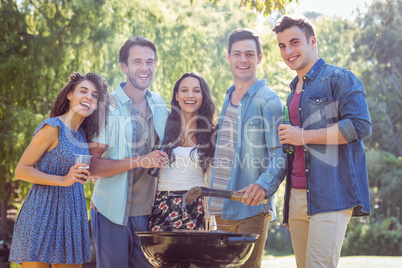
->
xmin=284 ymin=59 xmax=371 ymax=223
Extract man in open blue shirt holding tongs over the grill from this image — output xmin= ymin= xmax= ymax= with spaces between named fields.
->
xmin=209 ymin=29 xmax=286 ymax=267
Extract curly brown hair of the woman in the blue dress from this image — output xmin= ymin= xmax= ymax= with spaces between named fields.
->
xmin=49 ymin=72 xmax=109 ymax=141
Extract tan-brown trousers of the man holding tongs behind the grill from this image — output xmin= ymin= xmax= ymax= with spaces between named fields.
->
xmin=215 ymin=212 xmax=272 ymax=268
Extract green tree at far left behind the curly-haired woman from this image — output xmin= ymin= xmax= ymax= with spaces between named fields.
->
xmin=0 ymin=0 xmax=125 ymax=240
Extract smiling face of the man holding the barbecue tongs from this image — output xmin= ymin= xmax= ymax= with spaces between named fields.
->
xmin=226 ymin=39 xmax=262 ymax=81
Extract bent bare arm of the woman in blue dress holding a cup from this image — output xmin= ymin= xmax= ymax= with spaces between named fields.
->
xmin=15 ymin=124 xmax=89 ymax=186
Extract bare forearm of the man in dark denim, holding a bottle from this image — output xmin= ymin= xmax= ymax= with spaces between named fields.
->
xmin=278 ymin=123 xmax=348 ymax=145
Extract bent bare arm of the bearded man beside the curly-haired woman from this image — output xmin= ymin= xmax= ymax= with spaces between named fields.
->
xmin=89 ymin=142 xmax=168 ymax=178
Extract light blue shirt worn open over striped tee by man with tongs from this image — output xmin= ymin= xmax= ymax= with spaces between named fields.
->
xmin=211 ymin=80 xmax=286 ymax=221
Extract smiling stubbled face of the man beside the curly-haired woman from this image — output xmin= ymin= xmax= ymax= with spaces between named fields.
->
xmin=121 ymin=45 xmax=156 ymax=90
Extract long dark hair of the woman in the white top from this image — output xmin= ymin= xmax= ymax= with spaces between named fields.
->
xmin=162 ymin=72 xmax=215 ymax=174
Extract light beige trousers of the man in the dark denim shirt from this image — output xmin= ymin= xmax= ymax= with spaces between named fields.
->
xmin=289 ymin=188 xmax=353 ymax=268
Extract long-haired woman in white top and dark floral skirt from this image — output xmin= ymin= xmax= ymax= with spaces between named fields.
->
xmin=149 ymin=72 xmax=215 ymax=231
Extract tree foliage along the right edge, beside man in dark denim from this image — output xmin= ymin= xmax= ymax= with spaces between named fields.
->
xmin=352 ymin=0 xmax=402 ymax=222
